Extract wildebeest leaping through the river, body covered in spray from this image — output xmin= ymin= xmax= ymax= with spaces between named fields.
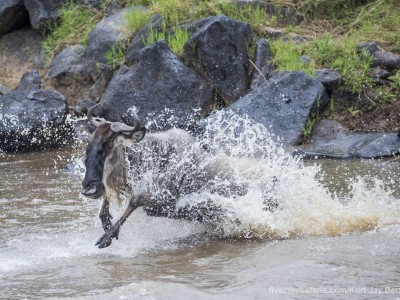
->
xmin=81 ymin=106 xmax=272 ymax=248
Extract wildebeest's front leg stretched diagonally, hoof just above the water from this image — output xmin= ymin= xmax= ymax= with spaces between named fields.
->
xmin=96 ymin=194 xmax=150 ymax=248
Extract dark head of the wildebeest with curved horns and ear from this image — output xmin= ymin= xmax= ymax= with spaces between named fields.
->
xmin=81 ymin=104 xmax=146 ymax=198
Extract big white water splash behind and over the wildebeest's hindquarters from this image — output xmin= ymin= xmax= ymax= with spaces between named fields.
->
xmin=125 ymin=112 xmax=400 ymax=238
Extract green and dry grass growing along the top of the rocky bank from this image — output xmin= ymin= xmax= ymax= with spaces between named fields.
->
xmin=43 ymin=0 xmax=400 ymax=134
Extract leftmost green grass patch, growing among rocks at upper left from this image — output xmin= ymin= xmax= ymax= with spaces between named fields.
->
xmin=42 ymin=1 xmax=101 ymax=61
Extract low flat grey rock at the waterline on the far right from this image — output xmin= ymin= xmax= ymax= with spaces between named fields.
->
xmin=294 ymin=120 xmax=400 ymax=159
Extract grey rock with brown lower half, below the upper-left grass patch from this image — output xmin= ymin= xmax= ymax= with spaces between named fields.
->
xmin=47 ymin=45 xmax=94 ymax=105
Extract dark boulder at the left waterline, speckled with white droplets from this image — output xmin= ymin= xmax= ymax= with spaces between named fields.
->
xmin=0 ymin=72 xmax=73 ymax=152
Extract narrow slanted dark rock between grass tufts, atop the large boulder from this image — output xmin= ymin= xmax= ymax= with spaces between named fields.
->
xmin=125 ymin=14 xmax=164 ymax=63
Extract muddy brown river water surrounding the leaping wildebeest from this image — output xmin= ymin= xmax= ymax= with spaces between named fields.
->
xmin=0 ymin=146 xmax=400 ymax=300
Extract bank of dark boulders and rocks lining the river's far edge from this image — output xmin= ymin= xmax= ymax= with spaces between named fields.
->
xmin=0 ymin=0 xmax=400 ymax=158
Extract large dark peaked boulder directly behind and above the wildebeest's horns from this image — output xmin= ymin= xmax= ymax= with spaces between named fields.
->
xmin=101 ymin=40 xmax=213 ymax=128
